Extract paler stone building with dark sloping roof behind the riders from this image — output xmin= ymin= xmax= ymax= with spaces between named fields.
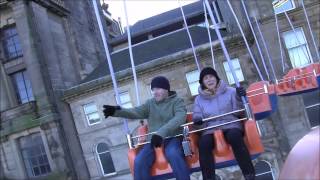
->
xmin=64 ymin=0 xmax=319 ymax=179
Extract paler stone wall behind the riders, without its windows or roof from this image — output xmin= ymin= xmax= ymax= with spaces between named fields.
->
xmin=66 ymin=1 xmax=319 ymax=179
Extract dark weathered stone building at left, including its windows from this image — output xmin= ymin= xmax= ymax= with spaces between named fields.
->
xmin=0 ymin=0 xmax=120 ymax=179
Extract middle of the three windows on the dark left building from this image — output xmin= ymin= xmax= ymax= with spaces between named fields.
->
xmin=11 ymin=71 xmax=34 ymax=104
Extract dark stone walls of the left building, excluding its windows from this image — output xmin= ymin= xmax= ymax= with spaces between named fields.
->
xmin=0 ymin=0 xmax=111 ymax=179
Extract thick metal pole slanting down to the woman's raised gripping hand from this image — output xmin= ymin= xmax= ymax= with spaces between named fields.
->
xmin=204 ymin=0 xmax=252 ymax=119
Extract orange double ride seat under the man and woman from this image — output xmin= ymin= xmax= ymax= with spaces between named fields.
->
xmin=128 ymin=113 xmax=264 ymax=177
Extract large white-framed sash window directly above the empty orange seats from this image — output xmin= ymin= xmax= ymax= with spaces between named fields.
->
xmin=282 ymin=27 xmax=311 ymax=68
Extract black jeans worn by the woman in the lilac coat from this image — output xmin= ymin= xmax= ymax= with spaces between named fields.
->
xmin=199 ymin=128 xmax=255 ymax=180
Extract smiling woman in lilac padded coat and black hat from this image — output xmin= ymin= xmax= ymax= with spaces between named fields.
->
xmin=193 ymin=67 xmax=255 ymax=180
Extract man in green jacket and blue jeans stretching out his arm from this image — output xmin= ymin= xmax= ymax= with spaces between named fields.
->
xmin=103 ymin=76 xmax=190 ymax=180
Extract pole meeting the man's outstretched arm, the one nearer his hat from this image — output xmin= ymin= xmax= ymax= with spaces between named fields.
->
xmin=123 ymin=0 xmax=140 ymax=106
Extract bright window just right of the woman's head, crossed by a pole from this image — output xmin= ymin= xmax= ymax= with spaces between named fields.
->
xmin=223 ymin=58 xmax=244 ymax=84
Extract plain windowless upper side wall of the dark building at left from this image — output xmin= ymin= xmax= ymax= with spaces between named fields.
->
xmin=64 ymin=1 xmax=108 ymax=79
